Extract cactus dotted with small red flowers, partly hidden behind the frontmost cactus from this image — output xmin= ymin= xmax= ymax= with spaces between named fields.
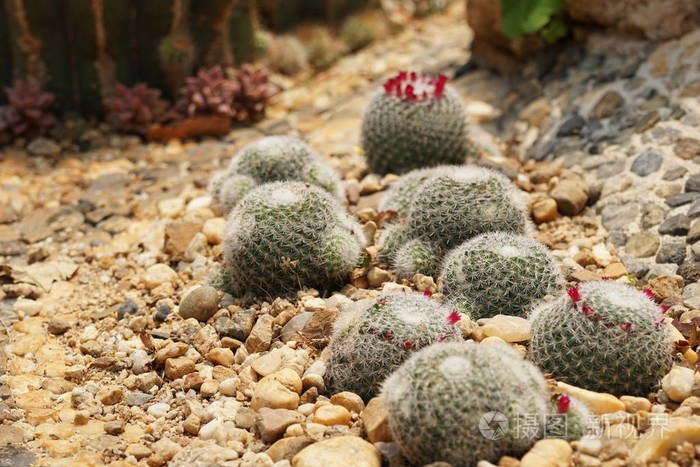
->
xmin=325 ymin=292 xmax=462 ymax=399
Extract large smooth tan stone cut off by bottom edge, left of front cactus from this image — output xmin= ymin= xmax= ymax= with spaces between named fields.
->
xmin=292 ymin=436 xmax=382 ymax=467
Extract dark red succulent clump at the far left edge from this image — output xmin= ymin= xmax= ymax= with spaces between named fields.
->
xmin=0 ymin=78 xmax=56 ymax=144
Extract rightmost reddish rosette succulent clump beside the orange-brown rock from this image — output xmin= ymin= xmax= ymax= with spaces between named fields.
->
xmin=176 ymin=65 xmax=277 ymax=122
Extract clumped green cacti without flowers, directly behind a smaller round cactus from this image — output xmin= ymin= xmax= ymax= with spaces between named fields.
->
xmin=379 ymin=167 xmax=530 ymax=277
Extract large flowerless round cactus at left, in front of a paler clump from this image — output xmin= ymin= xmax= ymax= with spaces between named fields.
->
xmin=219 ymin=182 xmax=364 ymax=297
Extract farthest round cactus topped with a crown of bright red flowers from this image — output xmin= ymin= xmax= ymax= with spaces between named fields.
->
xmin=362 ymin=72 xmax=469 ymax=174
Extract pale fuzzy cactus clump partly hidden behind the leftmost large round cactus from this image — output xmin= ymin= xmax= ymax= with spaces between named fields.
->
xmin=210 ymin=136 xmax=341 ymax=213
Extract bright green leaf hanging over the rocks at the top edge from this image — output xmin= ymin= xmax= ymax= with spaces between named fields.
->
xmin=501 ymin=0 xmax=564 ymax=38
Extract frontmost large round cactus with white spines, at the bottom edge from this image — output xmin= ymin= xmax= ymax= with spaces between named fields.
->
xmin=381 ymin=342 xmax=551 ymax=465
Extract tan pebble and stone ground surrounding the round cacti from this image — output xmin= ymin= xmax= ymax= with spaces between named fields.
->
xmin=0 ymin=2 xmax=700 ymax=467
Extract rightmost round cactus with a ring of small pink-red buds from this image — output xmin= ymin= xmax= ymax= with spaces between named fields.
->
xmin=529 ymin=281 xmax=672 ymax=395
